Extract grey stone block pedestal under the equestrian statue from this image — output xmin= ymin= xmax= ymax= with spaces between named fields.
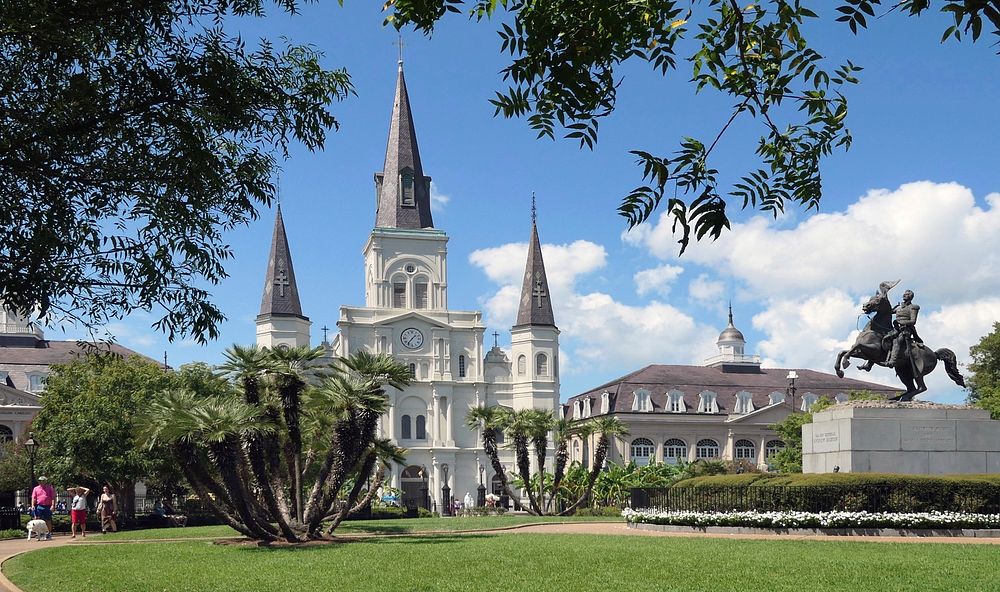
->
xmin=802 ymin=401 xmax=1000 ymax=475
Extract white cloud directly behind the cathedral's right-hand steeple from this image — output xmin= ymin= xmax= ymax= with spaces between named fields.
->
xmin=469 ymin=240 xmax=718 ymax=380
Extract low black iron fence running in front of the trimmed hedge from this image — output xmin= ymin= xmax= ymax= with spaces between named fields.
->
xmin=630 ymin=484 xmax=1000 ymax=514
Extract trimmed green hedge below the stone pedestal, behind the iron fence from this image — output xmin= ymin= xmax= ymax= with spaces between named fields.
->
xmin=632 ymin=473 xmax=1000 ymax=513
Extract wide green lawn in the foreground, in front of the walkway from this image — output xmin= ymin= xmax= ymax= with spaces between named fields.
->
xmin=4 ymin=534 xmax=1000 ymax=592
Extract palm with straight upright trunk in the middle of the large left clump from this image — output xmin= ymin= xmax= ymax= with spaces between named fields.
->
xmin=267 ymin=346 xmax=325 ymax=523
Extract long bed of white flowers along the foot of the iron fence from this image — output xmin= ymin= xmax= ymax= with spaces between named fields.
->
xmin=622 ymin=508 xmax=1000 ymax=529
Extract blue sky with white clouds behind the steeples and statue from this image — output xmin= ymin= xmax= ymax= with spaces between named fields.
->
xmin=62 ymin=2 xmax=1000 ymax=401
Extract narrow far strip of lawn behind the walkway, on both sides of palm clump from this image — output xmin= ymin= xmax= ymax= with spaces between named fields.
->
xmin=102 ymin=516 xmax=622 ymax=540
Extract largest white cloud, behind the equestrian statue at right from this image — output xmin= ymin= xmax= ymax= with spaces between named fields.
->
xmin=623 ymin=181 xmax=1000 ymax=400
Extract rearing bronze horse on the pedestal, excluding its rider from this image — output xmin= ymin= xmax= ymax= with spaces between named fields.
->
xmin=834 ymin=280 xmax=965 ymax=401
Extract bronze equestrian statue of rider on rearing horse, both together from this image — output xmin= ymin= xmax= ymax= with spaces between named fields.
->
xmin=834 ymin=280 xmax=965 ymax=401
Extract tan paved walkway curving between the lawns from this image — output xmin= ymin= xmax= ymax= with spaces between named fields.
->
xmin=0 ymin=522 xmax=1000 ymax=592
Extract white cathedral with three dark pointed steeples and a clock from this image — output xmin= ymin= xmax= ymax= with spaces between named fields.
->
xmin=257 ymin=62 xmax=559 ymax=508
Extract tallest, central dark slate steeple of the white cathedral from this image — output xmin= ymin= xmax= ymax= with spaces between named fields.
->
xmin=375 ymin=62 xmax=434 ymax=229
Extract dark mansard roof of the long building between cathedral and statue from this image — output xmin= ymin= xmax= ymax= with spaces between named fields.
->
xmin=567 ymin=364 xmax=900 ymax=415
